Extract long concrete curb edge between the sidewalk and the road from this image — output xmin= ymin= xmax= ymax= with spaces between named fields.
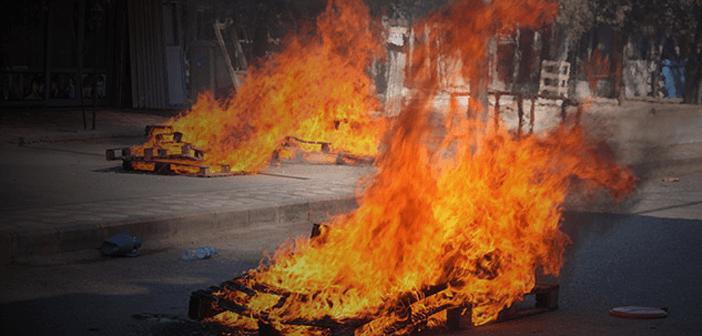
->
xmin=0 ymin=195 xmax=357 ymax=264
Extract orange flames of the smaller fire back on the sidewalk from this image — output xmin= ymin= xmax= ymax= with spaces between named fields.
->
xmin=171 ymin=1 xmax=386 ymax=172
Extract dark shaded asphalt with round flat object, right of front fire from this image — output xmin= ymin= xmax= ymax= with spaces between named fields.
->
xmin=452 ymin=213 xmax=702 ymax=335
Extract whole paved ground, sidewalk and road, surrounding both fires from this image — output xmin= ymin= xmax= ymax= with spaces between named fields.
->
xmin=0 ymin=105 xmax=702 ymax=335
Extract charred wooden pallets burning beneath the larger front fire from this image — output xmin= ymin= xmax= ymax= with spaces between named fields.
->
xmin=188 ymin=225 xmax=559 ymax=336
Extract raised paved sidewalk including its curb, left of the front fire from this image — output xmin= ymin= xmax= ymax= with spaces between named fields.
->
xmin=0 ymin=138 xmax=369 ymax=262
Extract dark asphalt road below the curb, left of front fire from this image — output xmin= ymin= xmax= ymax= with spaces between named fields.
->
xmin=0 ymin=223 xmax=311 ymax=336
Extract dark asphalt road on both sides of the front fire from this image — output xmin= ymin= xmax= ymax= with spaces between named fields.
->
xmin=0 ymin=213 xmax=702 ymax=335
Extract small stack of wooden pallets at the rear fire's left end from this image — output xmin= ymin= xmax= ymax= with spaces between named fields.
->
xmin=105 ymin=125 xmax=241 ymax=177
